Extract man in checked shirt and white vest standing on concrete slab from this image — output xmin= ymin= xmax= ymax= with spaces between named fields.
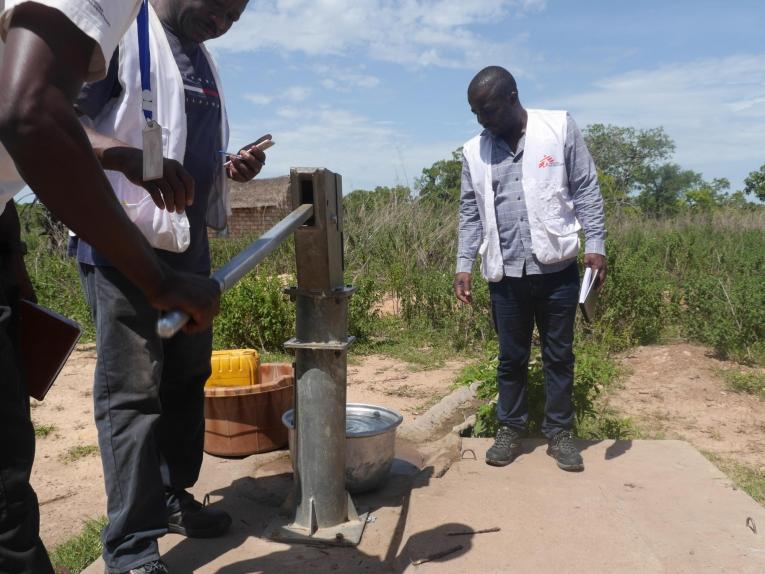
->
xmin=454 ymin=66 xmax=606 ymax=471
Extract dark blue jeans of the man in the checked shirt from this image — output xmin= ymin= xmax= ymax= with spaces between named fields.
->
xmin=489 ymin=262 xmax=579 ymax=438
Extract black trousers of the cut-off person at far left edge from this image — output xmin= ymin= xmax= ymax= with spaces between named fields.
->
xmin=0 ymin=254 xmax=53 ymax=574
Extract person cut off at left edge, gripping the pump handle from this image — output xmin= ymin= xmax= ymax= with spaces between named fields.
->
xmin=0 ymin=0 xmax=219 ymax=574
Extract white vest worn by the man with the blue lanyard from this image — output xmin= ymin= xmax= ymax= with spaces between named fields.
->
xmin=81 ymin=4 xmax=230 ymax=234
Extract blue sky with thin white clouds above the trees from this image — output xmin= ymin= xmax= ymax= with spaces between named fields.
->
xmin=209 ymin=0 xmax=765 ymax=193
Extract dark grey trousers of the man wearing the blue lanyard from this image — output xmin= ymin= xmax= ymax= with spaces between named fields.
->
xmin=80 ymin=265 xmax=212 ymax=573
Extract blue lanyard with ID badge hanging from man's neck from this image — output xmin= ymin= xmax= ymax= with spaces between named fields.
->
xmin=138 ymin=0 xmax=163 ymax=181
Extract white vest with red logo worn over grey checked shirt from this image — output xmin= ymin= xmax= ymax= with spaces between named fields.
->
xmin=463 ymin=110 xmax=581 ymax=282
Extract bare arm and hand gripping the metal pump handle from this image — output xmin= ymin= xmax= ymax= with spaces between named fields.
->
xmin=0 ymin=2 xmax=218 ymax=329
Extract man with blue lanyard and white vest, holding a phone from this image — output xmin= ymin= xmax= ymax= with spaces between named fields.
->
xmin=76 ymin=0 xmax=265 ymax=574
